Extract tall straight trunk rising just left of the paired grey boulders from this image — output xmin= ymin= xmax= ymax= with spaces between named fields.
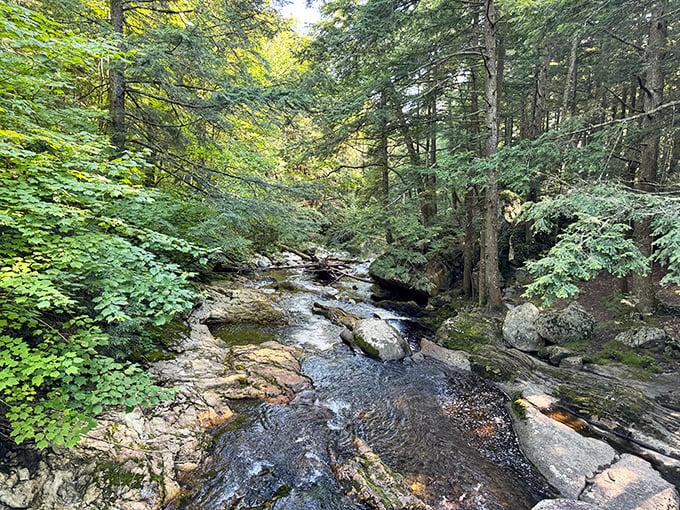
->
xmin=479 ymin=0 xmax=502 ymax=308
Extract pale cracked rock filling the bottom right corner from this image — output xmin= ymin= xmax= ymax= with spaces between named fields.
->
xmin=581 ymin=454 xmax=680 ymax=510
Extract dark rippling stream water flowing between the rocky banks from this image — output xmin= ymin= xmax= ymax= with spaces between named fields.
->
xmin=167 ymin=264 xmax=547 ymax=510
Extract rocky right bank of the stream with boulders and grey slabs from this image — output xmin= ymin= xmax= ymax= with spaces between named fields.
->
xmin=421 ymin=303 xmax=680 ymax=510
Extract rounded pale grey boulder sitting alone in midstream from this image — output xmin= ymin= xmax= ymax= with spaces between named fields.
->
xmin=352 ymin=319 xmax=411 ymax=361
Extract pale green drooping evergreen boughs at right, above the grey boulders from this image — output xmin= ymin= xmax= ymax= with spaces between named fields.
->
xmin=524 ymin=184 xmax=680 ymax=304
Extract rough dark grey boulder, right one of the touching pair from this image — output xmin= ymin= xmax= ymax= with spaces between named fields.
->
xmin=535 ymin=303 xmax=595 ymax=345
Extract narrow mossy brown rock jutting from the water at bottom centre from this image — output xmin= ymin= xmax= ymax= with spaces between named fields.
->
xmin=329 ymin=437 xmax=431 ymax=510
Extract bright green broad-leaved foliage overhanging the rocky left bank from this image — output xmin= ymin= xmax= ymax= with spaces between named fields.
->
xmin=0 ymin=4 xmax=202 ymax=448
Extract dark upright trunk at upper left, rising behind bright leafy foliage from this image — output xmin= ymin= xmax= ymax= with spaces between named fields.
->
xmin=109 ymin=0 xmax=127 ymax=154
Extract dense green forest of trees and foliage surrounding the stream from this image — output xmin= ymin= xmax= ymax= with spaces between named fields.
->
xmin=0 ymin=0 xmax=680 ymax=456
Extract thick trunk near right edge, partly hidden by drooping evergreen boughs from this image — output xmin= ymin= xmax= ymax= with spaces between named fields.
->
xmin=633 ymin=0 xmax=668 ymax=313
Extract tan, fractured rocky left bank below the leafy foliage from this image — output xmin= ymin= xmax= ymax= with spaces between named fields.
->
xmin=0 ymin=287 xmax=311 ymax=510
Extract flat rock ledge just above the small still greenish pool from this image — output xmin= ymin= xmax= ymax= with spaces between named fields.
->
xmin=192 ymin=286 xmax=286 ymax=325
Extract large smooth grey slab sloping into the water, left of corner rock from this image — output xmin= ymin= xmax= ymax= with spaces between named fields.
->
xmin=514 ymin=400 xmax=616 ymax=498
